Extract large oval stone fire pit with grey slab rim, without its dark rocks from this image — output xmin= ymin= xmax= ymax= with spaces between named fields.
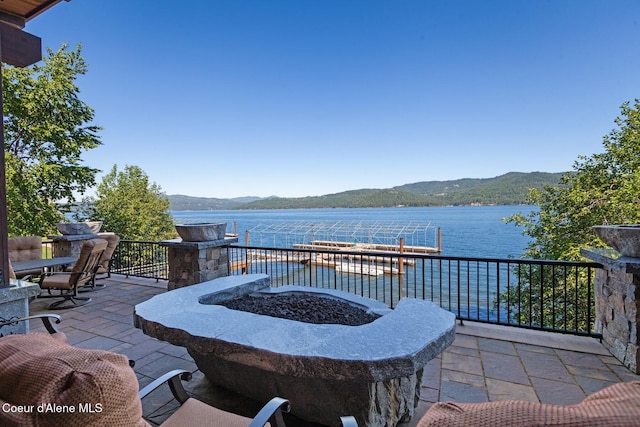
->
xmin=134 ymin=274 xmax=455 ymax=426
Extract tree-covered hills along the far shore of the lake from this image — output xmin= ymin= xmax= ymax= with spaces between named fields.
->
xmin=167 ymin=172 xmax=564 ymax=210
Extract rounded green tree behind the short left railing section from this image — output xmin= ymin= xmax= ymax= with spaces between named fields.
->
xmin=84 ymin=165 xmax=177 ymax=241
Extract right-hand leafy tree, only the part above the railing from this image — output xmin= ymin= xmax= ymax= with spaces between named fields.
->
xmin=509 ymin=100 xmax=640 ymax=260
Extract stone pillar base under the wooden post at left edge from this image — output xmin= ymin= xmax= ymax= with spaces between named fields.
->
xmin=0 ymin=280 xmax=40 ymax=337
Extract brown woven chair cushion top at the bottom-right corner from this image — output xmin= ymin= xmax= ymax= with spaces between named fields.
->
xmin=418 ymin=381 xmax=640 ymax=427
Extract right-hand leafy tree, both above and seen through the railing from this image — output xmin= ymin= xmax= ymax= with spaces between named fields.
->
xmin=501 ymin=100 xmax=640 ymax=330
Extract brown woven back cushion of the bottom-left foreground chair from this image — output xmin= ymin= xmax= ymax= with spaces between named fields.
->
xmin=0 ymin=333 xmax=148 ymax=427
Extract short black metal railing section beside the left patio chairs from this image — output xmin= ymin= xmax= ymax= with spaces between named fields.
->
xmin=111 ymin=240 xmax=169 ymax=280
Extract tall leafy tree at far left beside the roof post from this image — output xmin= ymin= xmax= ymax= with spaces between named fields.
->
xmin=2 ymin=45 xmax=101 ymax=235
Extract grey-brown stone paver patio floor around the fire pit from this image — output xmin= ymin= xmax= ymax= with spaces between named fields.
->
xmin=30 ymin=275 xmax=640 ymax=427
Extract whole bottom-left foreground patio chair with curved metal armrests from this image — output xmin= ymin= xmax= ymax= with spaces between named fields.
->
xmin=0 ymin=333 xmax=328 ymax=427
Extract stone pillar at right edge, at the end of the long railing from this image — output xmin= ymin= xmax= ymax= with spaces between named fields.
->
xmin=582 ymin=249 xmax=640 ymax=374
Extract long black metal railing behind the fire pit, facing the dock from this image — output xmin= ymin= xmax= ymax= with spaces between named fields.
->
xmin=229 ymin=246 xmax=601 ymax=337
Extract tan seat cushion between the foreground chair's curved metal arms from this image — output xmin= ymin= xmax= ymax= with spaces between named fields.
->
xmin=162 ymin=398 xmax=270 ymax=427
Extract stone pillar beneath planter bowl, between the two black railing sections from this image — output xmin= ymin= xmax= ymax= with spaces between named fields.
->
xmin=160 ymin=237 xmax=238 ymax=290
